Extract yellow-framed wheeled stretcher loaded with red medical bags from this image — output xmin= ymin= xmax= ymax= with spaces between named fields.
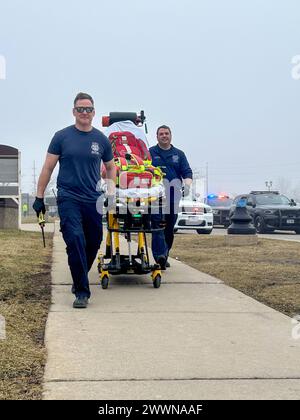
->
xmin=98 ymin=111 xmax=165 ymax=289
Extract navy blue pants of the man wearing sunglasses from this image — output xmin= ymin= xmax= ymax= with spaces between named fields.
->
xmin=57 ymin=197 xmax=103 ymax=298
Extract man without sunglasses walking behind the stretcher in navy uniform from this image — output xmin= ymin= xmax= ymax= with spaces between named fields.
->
xmin=149 ymin=125 xmax=193 ymax=270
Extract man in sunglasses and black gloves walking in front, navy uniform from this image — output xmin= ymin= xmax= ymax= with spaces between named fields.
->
xmin=33 ymin=93 xmax=116 ymax=308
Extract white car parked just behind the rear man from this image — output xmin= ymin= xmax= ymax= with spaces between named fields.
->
xmin=174 ymin=197 xmax=213 ymax=234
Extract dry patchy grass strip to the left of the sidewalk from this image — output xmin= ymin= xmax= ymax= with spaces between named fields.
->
xmin=0 ymin=230 xmax=52 ymax=400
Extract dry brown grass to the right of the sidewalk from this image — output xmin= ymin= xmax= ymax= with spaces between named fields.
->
xmin=170 ymin=233 xmax=300 ymax=317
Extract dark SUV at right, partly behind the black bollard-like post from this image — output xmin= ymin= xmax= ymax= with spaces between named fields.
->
xmin=230 ymin=191 xmax=300 ymax=233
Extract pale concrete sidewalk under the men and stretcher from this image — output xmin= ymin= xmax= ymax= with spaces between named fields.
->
xmin=44 ymin=225 xmax=300 ymax=399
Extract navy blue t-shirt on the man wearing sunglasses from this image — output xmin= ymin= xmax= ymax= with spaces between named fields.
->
xmin=48 ymin=125 xmax=113 ymax=202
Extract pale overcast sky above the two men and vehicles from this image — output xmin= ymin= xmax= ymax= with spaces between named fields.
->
xmin=0 ymin=0 xmax=300 ymax=194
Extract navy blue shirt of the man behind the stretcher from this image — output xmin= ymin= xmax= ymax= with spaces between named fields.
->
xmin=149 ymin=145 xmax=193 ymax=201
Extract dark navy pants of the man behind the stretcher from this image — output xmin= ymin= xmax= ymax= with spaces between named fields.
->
xmin=151 ymin=205 xmax=178 ymax=261
